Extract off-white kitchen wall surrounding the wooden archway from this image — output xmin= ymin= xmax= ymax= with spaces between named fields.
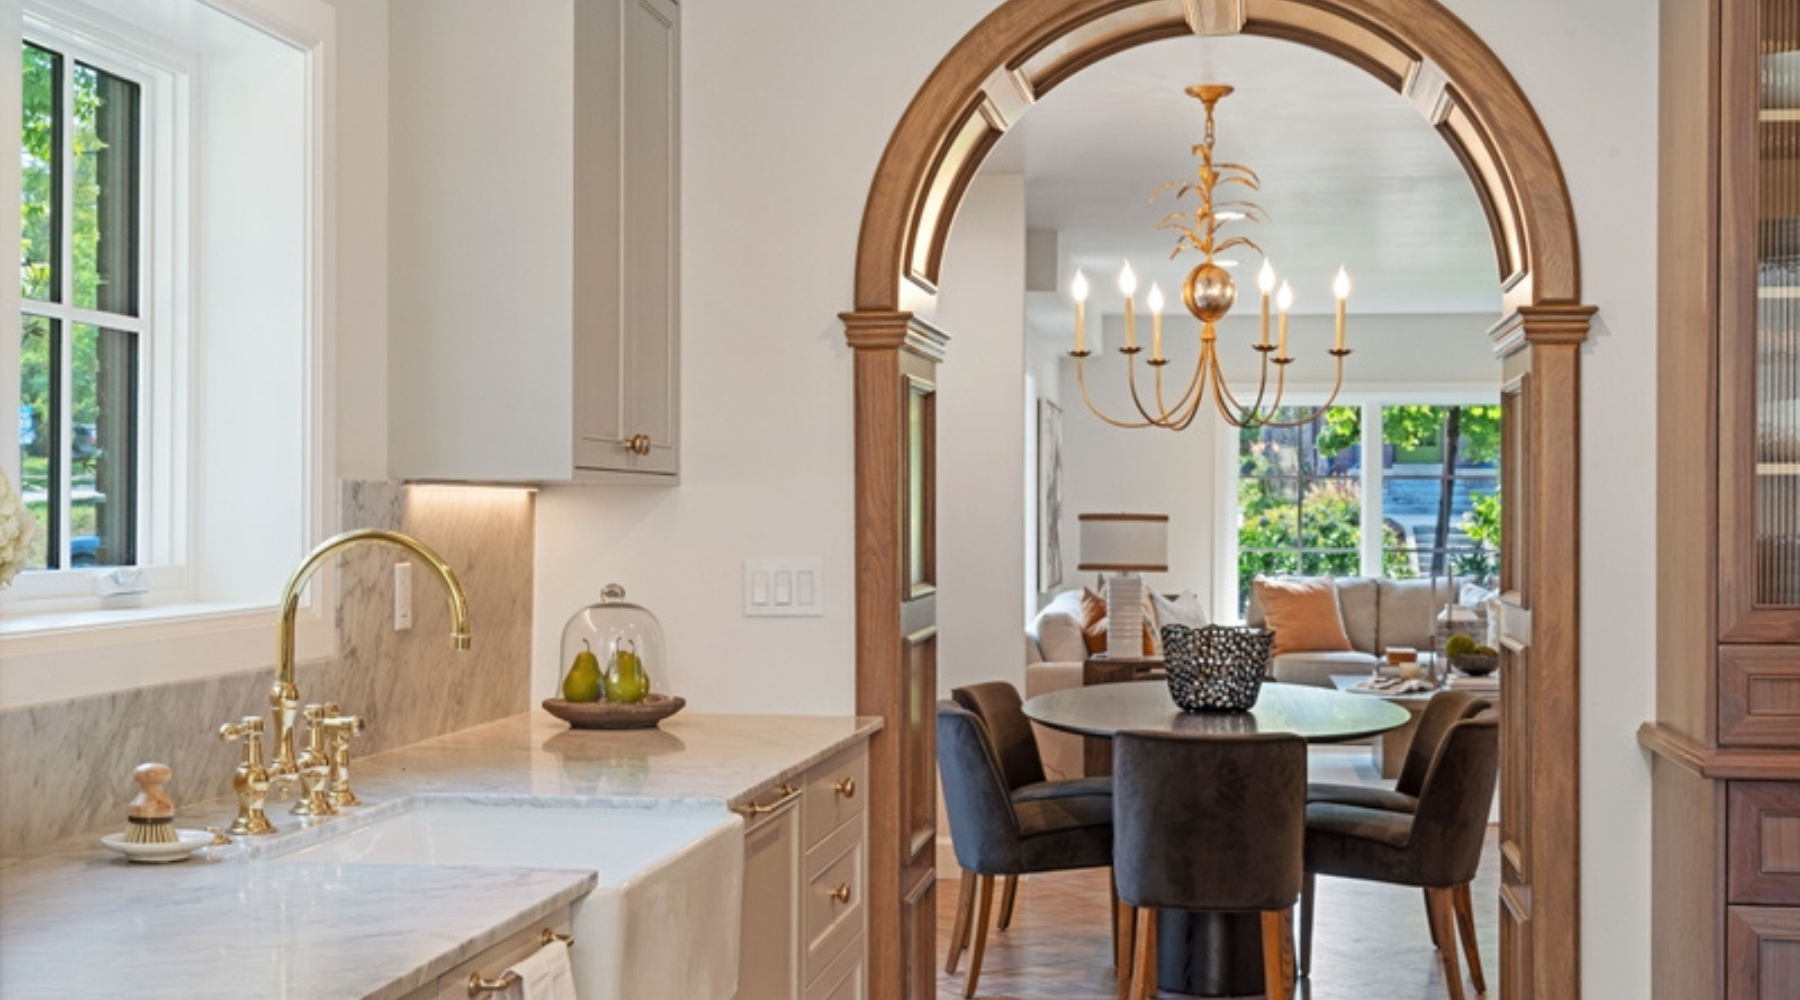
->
xmin=535 ymin=0 xmax=1656 ymax=996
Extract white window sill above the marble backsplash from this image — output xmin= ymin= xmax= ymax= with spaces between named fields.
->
xmin=0 ymin=603 xmax=337 ymax=710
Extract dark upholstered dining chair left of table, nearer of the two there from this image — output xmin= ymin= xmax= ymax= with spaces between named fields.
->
xmin=938 ymin=701 xmax=1112 ymax=996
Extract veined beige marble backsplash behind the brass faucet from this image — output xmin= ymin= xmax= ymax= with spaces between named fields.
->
xmin=0 ymin=482 xmax=535 ymax=856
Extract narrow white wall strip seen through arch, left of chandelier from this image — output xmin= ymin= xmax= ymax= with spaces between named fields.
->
xmin=938 ymin=174 xmax=1031 ymax=696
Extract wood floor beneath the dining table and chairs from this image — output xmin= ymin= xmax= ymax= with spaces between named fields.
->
xmin=938 ymin=746 xmax=1499 ymax=1000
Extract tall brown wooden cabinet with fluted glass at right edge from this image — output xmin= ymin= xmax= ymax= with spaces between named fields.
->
xmin=1648 ymin=0 xmax=1800 ymax=1000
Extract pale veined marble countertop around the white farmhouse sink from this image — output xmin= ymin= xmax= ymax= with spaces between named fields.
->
xmin=0 ymin=710 xmax=880 ymax=1000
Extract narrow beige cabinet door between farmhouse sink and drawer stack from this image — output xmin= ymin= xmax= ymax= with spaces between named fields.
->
xmin=738 ymin=800 xmax=801 ymax=1000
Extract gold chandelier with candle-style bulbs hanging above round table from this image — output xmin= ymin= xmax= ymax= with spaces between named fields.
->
xmin=1069 ymin=83 xmax=1350 ymax=430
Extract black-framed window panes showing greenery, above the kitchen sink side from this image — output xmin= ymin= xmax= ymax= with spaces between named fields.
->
xmin=18 ymin=40 xmax=143 ymax=570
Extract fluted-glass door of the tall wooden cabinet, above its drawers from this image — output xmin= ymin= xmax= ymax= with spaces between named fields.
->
xmin=1719 ymin=0 xmax=1800 ymax=642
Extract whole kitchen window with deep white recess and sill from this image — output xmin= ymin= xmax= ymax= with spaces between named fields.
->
xmin=0 ymin=0 xmax=337 ymax=709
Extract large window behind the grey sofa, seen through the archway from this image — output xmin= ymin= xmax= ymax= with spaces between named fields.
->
xmin=1237 ymin=399 xmax=1501 ymax=610
